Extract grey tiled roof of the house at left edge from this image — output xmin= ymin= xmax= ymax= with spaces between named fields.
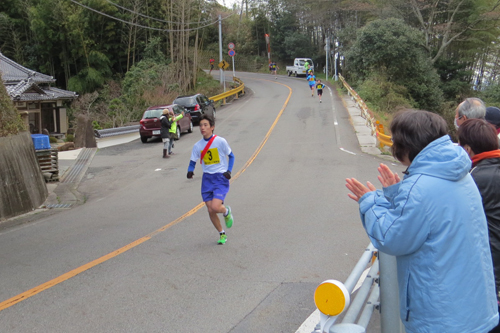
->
xmin=0 ymin=53 xmax=78 ymax=101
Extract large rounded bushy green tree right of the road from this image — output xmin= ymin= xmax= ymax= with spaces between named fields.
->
xmin=347 ymin=19 xmax=442 ymax=111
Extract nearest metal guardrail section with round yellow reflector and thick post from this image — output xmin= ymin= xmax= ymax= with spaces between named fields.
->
xmin=313 ymin=243 xmax=404 ymax=333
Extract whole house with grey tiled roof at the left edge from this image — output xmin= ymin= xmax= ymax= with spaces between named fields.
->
xmin=0 ymin=52 xmax=78 ymax=136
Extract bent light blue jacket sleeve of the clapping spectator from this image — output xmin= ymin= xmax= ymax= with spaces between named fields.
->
xmin=359 ymin=179 xmax=430 ymax=256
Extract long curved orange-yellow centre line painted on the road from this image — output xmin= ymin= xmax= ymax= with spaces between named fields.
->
xmin=0 ymin=79 xmax=292 ymax=311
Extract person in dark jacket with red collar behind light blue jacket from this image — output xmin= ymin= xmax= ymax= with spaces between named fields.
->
xmin=458 ymin=119 xmax=500 ymax=333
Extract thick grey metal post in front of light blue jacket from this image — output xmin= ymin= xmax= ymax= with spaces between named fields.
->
xmin=379 ymin=251 xmax=405 ymax=333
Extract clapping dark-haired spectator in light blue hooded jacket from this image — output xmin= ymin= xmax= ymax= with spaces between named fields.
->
xmin=346 ymin=110 xmax=498 ymax=333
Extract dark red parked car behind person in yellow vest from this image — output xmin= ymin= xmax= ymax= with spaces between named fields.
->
xmin=139 ymin=104 xmax=193 ymax=143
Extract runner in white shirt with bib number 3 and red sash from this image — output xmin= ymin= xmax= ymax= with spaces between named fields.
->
xmin=187 ymin=114 xmax=234 ymax=245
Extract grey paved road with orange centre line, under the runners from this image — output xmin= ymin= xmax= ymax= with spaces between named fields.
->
xmin=0 ymin=73 xmax=402 ymax=333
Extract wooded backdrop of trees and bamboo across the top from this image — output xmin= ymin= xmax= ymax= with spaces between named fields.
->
xmin=0 ymin=0 xmax=500 ymax=125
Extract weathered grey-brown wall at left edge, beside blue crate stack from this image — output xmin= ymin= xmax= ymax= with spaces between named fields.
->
xmin=0 ymin=132 xmax=48 ymax=221
